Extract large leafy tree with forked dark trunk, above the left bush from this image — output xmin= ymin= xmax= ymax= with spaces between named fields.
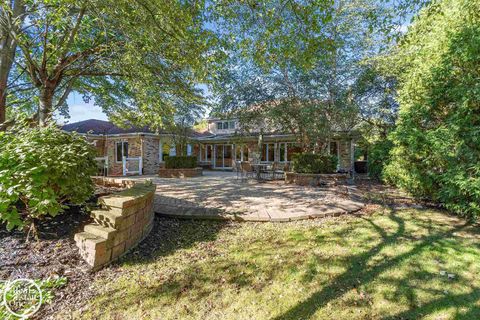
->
xmin=2 ymin=0 xmax=216 ymax=127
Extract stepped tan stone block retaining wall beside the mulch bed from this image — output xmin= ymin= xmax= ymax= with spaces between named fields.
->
xmin=75 ymin=183 xmax=155 ymax=269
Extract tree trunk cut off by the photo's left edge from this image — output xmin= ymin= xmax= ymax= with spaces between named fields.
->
xmin=0 ymin=0 xmax=25 ymax=127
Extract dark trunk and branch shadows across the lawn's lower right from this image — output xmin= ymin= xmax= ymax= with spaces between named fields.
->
xmin=274 ymin=210 xmax=480 ymax=320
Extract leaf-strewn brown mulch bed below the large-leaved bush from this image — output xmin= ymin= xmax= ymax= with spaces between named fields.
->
xmin=0 ymin=187 xmax=122 ymax=319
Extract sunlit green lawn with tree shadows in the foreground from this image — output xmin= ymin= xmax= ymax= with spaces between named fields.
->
xmin=72 ymin=209 xmax=480 ymax=320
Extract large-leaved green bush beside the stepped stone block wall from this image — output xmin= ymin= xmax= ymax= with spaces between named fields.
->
xmin=0 ymin=125 xmax=96 ymax=230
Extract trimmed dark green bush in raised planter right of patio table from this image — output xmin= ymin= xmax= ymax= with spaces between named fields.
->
xmin=292 ymin=153 xmax=337 ymax=173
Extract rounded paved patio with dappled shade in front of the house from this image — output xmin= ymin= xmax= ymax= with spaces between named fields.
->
xmin=127 ymin=171 xmax=364 ymax=222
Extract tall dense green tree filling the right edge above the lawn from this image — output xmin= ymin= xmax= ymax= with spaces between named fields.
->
xmin=385 ymin=0 xmax=480 ymax=218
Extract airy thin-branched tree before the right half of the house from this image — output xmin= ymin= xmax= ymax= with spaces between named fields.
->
xmin=215 ymin=0 xmax=389 ymax=151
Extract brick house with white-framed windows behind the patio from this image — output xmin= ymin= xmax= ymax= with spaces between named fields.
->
xmin=62 ymin=118 xmax=355 ymax=176
